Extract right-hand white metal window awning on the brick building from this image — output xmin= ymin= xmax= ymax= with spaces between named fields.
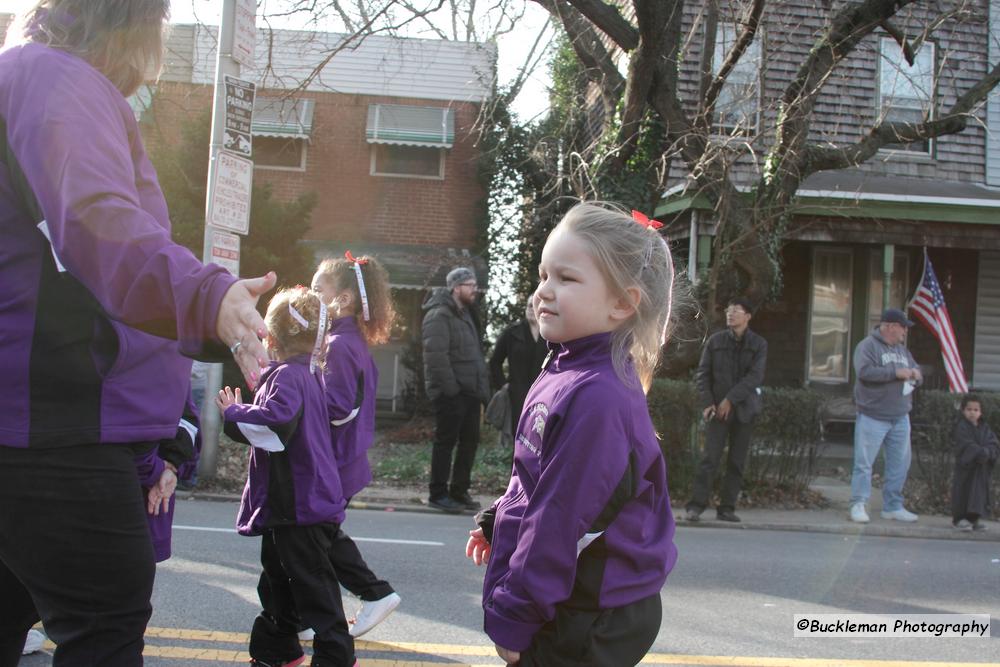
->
xmin=365 ymin=104 xmax=455 ymax=148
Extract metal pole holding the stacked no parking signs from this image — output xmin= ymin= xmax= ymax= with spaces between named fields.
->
xmin=198 ymin=0 xmax=257 ymax=479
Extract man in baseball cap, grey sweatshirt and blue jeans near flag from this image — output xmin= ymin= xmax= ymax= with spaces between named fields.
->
xmin=851 ymin=308 xmax=923 ymax=523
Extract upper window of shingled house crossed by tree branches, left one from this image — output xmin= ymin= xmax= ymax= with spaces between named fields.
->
xmin=712 ymin=23 xmax=761 ymax=133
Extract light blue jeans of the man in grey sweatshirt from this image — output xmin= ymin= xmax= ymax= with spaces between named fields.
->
xmin=851 ymin=413 xmax=910 ymax=512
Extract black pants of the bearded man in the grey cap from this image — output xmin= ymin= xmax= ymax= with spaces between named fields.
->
xmin=430 ymin=394 xmax=481 ymax=498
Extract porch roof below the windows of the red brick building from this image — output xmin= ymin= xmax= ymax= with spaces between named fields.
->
xmin=304 ymin=241 xmax=488 ymax=291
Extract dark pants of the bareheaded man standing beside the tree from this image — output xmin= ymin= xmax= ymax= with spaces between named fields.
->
xmin=687 ymin=414 xmax=753 ymax=512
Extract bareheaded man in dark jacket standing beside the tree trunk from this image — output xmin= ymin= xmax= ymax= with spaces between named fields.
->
xmin=687 ymin=299 xmax=767 ymax=521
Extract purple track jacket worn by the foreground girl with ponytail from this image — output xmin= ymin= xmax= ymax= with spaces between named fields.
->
xmin=483 ymin=334 xmax=677 ymax=651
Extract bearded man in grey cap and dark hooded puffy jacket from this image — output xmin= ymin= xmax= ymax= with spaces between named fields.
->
xmin=422 ymin=267 xmax=490 ymax=513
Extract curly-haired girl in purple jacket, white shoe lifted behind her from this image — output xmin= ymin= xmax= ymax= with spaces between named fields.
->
xmin=313 ymin=250 xmax=400 ymax=637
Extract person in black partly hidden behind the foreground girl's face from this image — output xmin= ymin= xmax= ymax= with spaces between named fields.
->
xmin=490 ymin=300 xmax=549 ymax=433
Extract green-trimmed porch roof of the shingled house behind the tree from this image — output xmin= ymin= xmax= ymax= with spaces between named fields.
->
xmin=656 ymin=170 xmax=1000 ymax=225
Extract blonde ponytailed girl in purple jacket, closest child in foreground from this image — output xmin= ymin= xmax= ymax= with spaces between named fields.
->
xmin=466 ymin=204 xmax=677 ymax=667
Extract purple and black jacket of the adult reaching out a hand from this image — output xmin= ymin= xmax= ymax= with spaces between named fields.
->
xmin=0 ymin=44 xmax=236 ymax=447
